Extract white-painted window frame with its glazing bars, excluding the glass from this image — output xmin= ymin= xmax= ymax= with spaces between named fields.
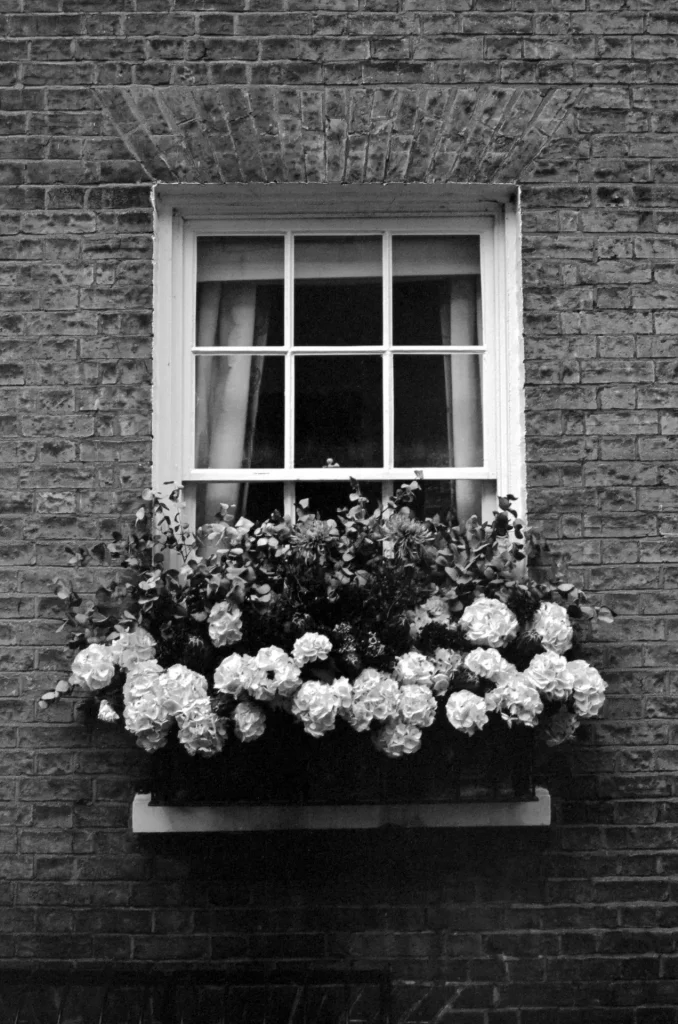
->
xmin=153 ymin=184 xmax=525 ymax=518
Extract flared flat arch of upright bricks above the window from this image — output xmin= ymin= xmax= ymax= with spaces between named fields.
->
xmin=97 ymin=85 xmax=581 ymax=184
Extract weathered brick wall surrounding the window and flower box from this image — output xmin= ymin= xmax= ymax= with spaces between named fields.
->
xmin=0 ymin=0 xmax=678 ymax=1024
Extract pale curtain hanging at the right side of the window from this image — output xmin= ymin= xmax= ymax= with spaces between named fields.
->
xmin=440 ymin=276 xmax=483 ymax=525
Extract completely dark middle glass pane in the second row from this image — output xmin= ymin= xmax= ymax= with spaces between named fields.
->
xmin=294 ymin=355 xmax=383 ymax=469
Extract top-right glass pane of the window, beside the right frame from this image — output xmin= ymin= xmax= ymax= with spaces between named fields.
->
xmin=393 ymin=237 xmax=480 ymax=345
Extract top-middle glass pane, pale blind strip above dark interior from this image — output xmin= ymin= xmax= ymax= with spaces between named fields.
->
xmin=294 ymin=238 xmax=382 ymax=346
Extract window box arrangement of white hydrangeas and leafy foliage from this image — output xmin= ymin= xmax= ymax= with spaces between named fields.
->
xmin=41 ymin=481 xmax=611 ymax=770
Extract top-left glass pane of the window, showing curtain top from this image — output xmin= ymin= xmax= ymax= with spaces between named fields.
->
xmin=196 ymin=239 xmax=284 ymax=347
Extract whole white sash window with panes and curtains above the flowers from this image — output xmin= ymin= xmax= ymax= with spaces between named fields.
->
xmin=154 ymin=185 xmax=522 ymax=524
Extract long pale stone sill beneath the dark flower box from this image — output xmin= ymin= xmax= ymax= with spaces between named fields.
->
xmin=132 ymin=786 xmax=551 ymax=834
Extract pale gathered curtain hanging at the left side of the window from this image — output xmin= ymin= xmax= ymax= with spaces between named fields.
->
xmin=196 ymin=282 xmax=270 ymax=522
